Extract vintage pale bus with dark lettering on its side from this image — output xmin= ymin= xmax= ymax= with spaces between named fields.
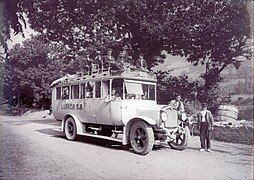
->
xmin=51 ymin=69 xmax=189 ymax=155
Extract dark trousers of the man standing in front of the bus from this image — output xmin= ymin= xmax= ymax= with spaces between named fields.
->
xmin=200 ymin=122 xmax=212 ymax=149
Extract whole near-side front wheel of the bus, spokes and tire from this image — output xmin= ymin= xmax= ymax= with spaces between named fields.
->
xmin=130 ymin=121 xmax=154 ymax=155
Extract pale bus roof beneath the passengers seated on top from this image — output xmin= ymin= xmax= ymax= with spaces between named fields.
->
xmin=50 ymin=69 xmax=157 ymax=87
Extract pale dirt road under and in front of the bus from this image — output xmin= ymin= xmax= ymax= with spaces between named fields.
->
xmin=0 ymin=112 xmax=253 ymax=179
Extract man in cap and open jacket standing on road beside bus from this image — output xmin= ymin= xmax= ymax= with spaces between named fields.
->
xmin=197 ymin=103 xmax=214 ymax=152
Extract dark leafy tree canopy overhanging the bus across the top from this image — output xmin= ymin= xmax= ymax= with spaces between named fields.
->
xmin=1 ymin=0 xmax=251 ymax=105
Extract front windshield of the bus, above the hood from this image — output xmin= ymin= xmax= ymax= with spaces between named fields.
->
xmin=125 ymin=82 xmax=155 ymax=100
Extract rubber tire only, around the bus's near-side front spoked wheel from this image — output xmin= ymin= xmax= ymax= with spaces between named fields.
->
xmin=130 ymin=121 xmax=154 ymax=155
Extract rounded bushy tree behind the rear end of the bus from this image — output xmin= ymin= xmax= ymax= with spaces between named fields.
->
xmin=4 ymin=35 xmax=75 ymax=106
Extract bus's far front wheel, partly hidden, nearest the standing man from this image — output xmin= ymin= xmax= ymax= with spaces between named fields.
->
xmin=168 ymin=126 xmax=190 ymax=150
